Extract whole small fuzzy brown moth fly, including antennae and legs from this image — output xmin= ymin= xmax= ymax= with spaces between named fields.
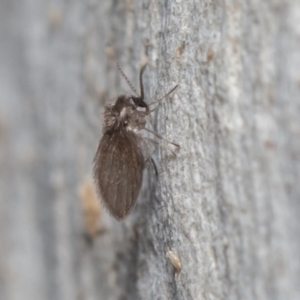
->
xmin=94 ymin=65 xmax=179 ymax=220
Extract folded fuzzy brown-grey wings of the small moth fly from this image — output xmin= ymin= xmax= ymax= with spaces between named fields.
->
xmin=94 ymin=131 xmax=145 ymax=220
